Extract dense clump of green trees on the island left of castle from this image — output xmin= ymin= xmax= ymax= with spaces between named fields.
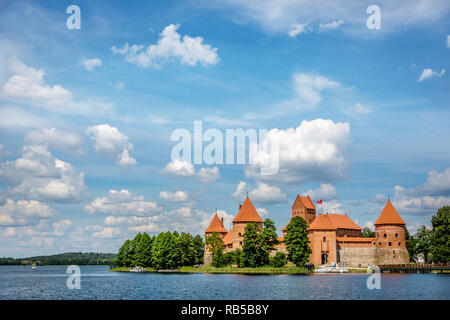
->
xmin=111 ymin=231 xmax=204 ymax=270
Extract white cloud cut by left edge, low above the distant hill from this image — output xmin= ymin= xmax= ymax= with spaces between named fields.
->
xmin=0 ymin=199 xmax=58 ymax=226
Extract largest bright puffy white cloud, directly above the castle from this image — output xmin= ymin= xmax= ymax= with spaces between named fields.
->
xmin=245 ymin=119 xmax=350 ymax=184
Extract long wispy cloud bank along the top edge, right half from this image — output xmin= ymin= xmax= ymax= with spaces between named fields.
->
xmin=202 ymin=0 xmax=450 ymax=35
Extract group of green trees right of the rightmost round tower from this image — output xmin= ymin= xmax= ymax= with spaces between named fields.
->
xmin=406 ymin=206 xmax=450 ymax=263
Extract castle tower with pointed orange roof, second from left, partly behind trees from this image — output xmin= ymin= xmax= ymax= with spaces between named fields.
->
xmin=231 ymin=196 xmax=263 ymax=249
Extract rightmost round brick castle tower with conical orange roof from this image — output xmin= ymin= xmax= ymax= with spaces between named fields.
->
xmin=375 ymin=200 xmax=409 ymax=265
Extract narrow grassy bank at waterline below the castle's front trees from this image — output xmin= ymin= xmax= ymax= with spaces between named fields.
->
xmin=180 ymin=266 xmax=313 ymax=274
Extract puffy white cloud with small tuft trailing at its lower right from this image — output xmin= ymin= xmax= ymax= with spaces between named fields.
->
xmin=86 ymin=124 xmax=136 ymax=166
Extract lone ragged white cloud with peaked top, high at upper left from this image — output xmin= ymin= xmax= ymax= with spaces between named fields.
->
xmin=111 ymin=24 xmax=219 ymax=67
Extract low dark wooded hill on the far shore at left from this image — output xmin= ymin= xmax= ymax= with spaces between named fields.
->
xmin=0 ymin=252 xmax=116 ymax=266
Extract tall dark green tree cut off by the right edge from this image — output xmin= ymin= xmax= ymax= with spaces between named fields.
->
xmin=431 ymin=206 xmax=450 ymax=263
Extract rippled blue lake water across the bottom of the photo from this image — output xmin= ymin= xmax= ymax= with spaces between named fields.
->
xmin=0 ymin=266 xmax=450 ymax=300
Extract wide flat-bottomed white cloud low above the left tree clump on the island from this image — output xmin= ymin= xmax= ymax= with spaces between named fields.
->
xmin=84 ymin=190 xmax=161 ymax=216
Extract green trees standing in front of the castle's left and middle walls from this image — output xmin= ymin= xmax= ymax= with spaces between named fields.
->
xmin=205 ymin=217 xmax=311 ymax=268
